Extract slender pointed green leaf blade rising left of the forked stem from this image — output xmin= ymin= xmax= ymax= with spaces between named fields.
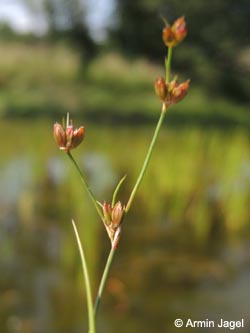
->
xmin=72 ymin=220 xmax=95 ymax=333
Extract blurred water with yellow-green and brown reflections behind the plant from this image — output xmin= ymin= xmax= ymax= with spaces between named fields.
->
xmin=0 ymin=123 xmax=250 ymax=333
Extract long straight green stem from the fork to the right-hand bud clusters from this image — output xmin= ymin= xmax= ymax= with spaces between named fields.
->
xmin=125 ymin=104 xmax=167 ymax=213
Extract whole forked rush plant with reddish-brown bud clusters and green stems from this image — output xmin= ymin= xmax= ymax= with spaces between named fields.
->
xmin=54 ymin=17 xmax=189 ymax=333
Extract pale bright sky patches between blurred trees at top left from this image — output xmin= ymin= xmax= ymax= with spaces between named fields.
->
xmin=0 ymin=0 xmax=115 ymax=39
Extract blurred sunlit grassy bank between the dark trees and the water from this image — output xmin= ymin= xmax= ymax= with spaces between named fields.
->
xmin=0 ymin=42 xmax=250 ymax=127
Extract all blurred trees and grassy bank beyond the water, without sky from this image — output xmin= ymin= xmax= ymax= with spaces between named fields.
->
xmin=0 ymin=0 xmax=250 ymax=127
